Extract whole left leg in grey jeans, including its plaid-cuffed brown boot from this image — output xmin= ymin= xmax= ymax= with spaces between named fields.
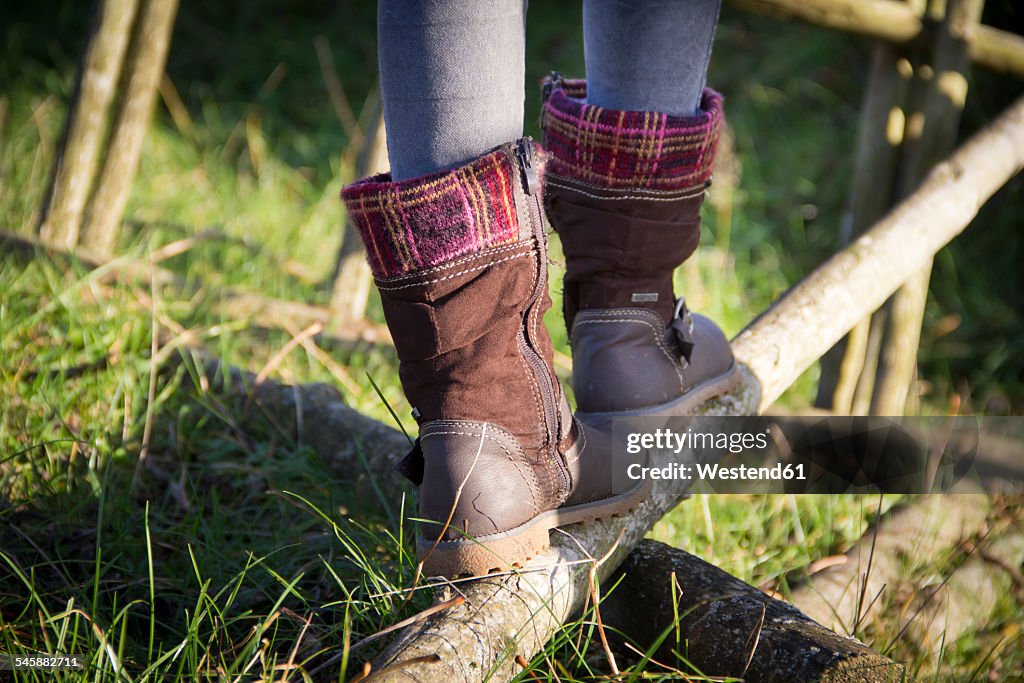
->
xmin=342 ymin=0 xmax=643 ymax=577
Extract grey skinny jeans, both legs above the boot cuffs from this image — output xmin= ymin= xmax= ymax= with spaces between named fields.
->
xmin=377 ymin=0 xmax=721 ymax=180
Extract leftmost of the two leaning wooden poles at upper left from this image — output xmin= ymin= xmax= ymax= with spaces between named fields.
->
xmin=39 ymin=0 xmax=138 ymax=249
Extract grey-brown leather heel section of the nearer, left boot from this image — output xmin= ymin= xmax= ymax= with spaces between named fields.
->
xmin=419 ymin=420 xmax=550 ymax=541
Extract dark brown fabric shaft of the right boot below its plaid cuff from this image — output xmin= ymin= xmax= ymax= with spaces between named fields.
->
xmin=546 ymin=174 xmax=703 ymax=327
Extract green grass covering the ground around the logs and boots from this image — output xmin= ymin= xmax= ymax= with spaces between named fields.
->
xmin=0 ymin=0 xmax=1024 ymax=681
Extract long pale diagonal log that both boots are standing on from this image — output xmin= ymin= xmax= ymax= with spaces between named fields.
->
xmin=360 ymin=94 xmax=1024 ymax=683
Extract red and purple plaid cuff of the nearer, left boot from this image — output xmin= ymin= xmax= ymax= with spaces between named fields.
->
xmin=341 ymin=150 xmax=519 ymax=279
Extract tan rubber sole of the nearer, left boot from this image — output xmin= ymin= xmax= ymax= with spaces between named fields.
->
xmin=416 ymin=480 xmax=651 ymax=579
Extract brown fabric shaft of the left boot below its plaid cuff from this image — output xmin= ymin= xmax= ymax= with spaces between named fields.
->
xmin=378 ymin=242 xmax=547 ymax=451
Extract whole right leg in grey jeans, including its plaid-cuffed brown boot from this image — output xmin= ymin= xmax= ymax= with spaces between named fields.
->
xmin=542 ymin=0 xmax=737 ymax=417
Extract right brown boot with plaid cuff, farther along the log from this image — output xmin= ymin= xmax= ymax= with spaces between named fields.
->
xmin=542 ymin=74 xmax=738 ymax=417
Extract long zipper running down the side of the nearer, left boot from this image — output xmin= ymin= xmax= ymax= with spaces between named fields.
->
xmin=515 ymin=137 xmax=569 ymax=493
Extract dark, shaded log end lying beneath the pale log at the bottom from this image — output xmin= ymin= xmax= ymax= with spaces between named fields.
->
xmin=601 ymin=541 xmax=903 ymax=683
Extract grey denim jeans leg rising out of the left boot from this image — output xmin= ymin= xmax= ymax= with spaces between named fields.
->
xmin=377 ymin=0 xmax=525 ymax=180
